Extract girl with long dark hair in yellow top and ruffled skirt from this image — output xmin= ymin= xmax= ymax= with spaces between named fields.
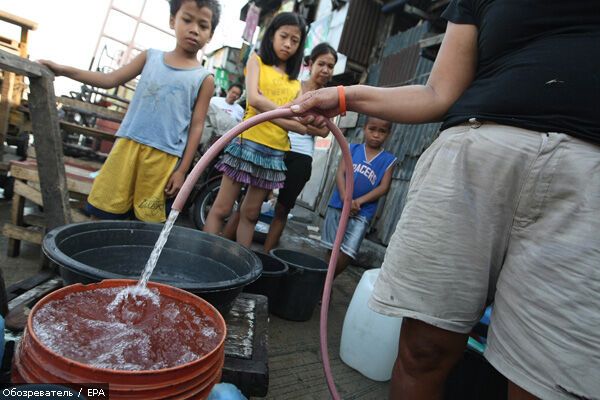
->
xmin=204 ymin=12 xmax=324 ymax=247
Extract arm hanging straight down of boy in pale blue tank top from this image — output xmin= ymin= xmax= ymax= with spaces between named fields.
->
xmin=165 ymin=75 xmax=215 ymax=197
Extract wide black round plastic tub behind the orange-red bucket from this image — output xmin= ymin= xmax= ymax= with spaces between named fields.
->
xmin=42 ymin=221 xmax=262 ymax=313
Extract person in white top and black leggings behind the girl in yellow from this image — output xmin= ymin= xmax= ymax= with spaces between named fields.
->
xmin=264 ymin=43 xmax=337 ymax=252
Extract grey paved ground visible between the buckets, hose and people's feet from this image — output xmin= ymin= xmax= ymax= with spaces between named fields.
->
xmin=0 ymin=189 xmax=388 ymax=400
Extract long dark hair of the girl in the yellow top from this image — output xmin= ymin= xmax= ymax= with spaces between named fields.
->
xmin=258 ymin=12 xmax=306 ymax=79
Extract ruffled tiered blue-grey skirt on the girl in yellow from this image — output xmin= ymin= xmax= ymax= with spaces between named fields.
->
xmin=216 ymin=138 xmax=286 ymax=190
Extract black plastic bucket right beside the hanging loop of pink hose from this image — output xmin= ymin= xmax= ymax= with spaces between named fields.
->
xmin=270 ymin=249 xmax=327 ymax=321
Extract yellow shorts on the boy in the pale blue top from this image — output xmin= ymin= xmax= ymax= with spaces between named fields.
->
xmin=87 ymin=138 xmax=178 ymax=222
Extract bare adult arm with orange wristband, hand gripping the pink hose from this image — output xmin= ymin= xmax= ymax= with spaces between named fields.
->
xmin=292 ymin=22 xmax=477 ymax=126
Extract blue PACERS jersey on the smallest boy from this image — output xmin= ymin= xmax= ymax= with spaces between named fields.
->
xmin=329 ymin=143 xmax=396 ymax=221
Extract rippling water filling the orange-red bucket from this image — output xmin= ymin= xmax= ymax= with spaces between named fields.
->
xmin=33 ymin=287 xmax=222 ymax=371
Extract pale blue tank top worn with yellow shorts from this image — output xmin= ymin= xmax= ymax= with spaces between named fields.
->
xmin=117 ymin=49 xmax=209 ymax=157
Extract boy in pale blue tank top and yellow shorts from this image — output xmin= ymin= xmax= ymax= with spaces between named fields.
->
xmin=40 ymin=0 xmax=221 ymax=222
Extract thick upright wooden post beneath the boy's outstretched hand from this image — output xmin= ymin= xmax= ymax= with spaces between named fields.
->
xmin=29 ymin=73 xmax=71 ymax=229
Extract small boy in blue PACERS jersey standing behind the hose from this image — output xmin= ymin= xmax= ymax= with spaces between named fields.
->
xmin=321 ymin=117 xmax=396 ymax=276
